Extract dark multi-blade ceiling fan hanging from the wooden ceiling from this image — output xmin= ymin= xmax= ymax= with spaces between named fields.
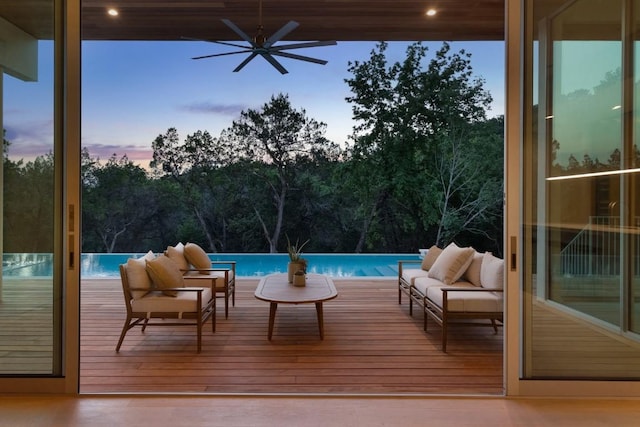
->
xmin=185 ymin=0 xmax=337 ymax=74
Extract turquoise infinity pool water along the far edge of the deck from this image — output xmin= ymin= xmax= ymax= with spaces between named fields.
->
xmin=3 ymin=253 xmax=420 ymax=278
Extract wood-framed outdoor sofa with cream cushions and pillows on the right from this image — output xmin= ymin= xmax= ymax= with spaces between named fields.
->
xmin=398 ymin=243 xmax=504 ymax=352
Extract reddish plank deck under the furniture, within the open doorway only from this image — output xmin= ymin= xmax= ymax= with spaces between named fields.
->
xmin=80 ymin=280 xmax=503 ymax=395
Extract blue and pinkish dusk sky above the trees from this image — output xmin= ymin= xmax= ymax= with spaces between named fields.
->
xmin=4 ymin=41 xmax=504 ymax=165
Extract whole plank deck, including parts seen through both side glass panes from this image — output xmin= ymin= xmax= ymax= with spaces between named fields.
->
xmin=10 ymin=279 xmax=640 ymax=395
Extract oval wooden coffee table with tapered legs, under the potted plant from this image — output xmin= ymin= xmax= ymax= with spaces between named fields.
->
xmin=255 ymin=274 xmax=338 ymax=340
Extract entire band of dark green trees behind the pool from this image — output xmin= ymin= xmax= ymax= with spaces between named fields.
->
xmin=5 ymin=43 xmax=504 ymax=255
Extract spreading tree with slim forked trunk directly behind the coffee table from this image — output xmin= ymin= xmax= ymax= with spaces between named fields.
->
xmin=220 ymin=94 xmax=338 ymax=253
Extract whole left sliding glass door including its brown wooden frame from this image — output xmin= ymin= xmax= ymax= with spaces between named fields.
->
xmin=0 ymin=0 xmax=80 ymax=393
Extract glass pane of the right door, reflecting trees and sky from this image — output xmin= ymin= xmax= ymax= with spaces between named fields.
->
xmin=523 ymin=0 xmax=640 ymax=379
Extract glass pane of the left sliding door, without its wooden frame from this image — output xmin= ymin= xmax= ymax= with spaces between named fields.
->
xmin=0 ymin=1 xmax=61 ymax=375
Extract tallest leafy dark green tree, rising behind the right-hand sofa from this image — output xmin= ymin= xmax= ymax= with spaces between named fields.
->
xmin=346 ymin=43 xmax=502 ymax=252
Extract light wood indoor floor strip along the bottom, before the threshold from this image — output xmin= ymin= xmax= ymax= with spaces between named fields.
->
xmin=0 ymin=396 xmax=640 ymax=427
